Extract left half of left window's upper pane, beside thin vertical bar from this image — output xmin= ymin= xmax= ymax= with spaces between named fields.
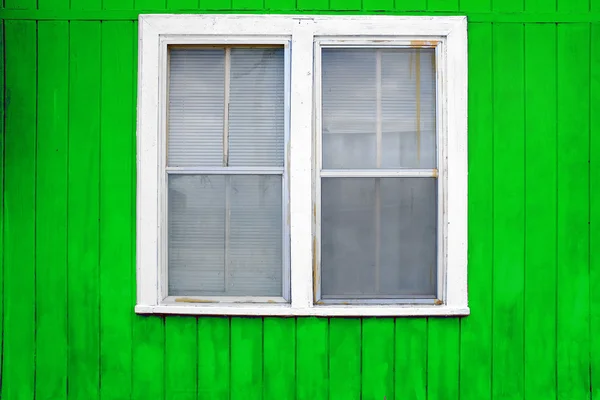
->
xmin=167 ymin=49 xmax=225 ymax=167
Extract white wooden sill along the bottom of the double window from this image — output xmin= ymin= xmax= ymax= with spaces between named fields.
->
xmin=135 ymin=304 xmax=470 ymax=317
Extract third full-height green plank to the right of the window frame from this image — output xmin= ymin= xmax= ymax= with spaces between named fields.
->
xmin=525 ymin=24 xmax=556 ymax=399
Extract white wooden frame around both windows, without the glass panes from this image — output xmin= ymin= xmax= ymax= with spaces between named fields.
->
xmin=135 ymin=14 xmax=469 ymax=316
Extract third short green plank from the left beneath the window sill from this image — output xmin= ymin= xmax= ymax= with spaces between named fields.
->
xmin=198 ymin=317 xmax=231 ymax=400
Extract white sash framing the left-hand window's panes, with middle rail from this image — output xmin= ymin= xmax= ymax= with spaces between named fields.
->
xmin=158 ymin=38 xmax=291 ymax=303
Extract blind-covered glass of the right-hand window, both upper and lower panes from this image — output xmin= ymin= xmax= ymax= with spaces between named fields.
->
xmin=320 ymin=47 xmax=438 ymax=300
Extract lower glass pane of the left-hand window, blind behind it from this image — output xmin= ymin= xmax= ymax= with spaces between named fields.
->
xmin=168 ymin=175 xmax=283 ymax=296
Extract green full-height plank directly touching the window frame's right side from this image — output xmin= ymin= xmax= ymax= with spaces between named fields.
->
xmin=460 ymin=21 xmax=494 ymax=400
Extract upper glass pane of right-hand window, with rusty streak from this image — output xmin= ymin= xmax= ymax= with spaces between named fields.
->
xmin=322 ymin=48 xmax=436 ymax=169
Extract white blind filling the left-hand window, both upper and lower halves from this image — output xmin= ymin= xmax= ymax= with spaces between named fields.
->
xmin=167 ymin=47 xmax=285 ymax=297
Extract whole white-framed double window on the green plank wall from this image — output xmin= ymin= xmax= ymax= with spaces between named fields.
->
xmin=136 ymin=15 xmax=469 ymax=316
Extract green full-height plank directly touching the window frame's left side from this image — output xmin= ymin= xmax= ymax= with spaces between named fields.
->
xmin=100 ymin=21 xmax=135 ymax=400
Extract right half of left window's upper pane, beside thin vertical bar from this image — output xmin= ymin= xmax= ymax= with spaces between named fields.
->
xmin=229 ymin=48 xmax=284 ymax=167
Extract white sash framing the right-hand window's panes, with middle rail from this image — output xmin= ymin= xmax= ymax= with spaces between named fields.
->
xmin=313 ymin=37 xmax=447 ymax=305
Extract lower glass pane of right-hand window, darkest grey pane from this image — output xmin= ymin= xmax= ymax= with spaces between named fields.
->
xmin=321 ymin=178 xmax=437 ymax=298
